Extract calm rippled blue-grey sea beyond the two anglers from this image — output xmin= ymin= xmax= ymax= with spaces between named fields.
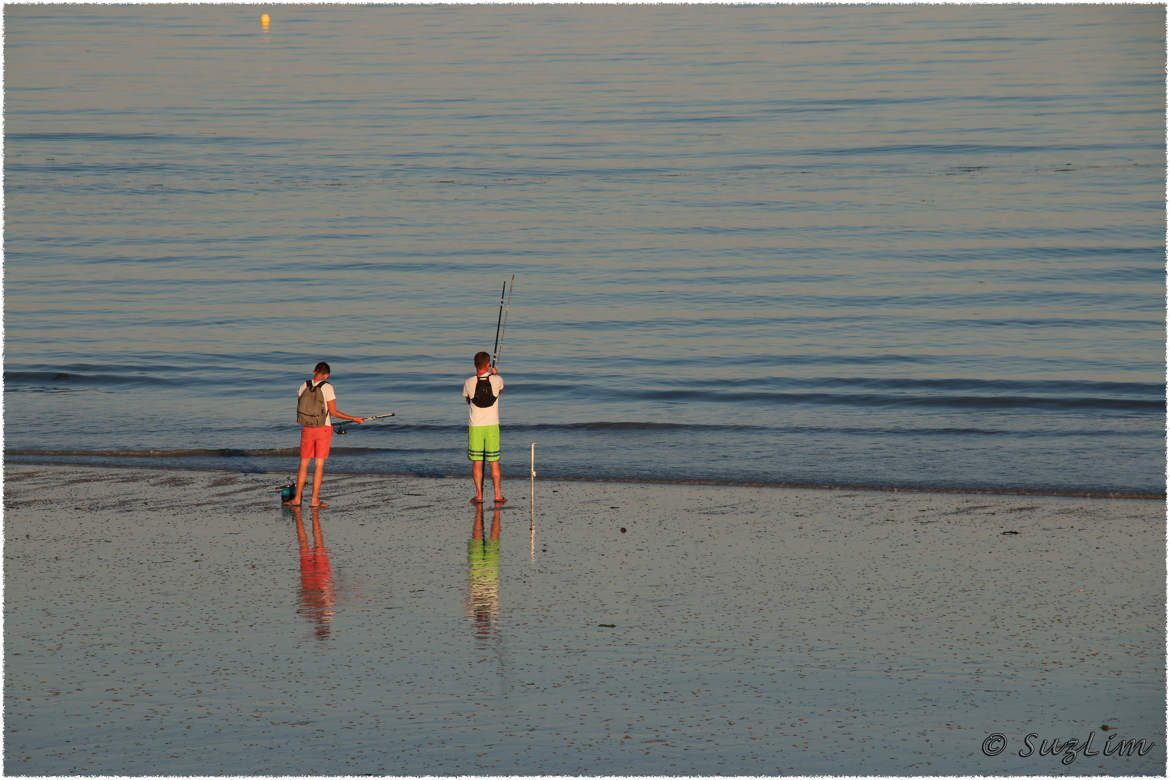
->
xmin=4 ymin=5 xmax=1166 ymax=493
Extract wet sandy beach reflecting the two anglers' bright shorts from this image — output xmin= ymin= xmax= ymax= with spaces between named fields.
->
xmin=4 ymin=464 xmax=1165 ymax=775
